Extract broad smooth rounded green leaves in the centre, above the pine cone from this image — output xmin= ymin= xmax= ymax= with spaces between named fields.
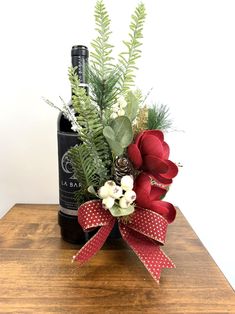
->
xmin=110 ymin=116 xmax=133 ymax=148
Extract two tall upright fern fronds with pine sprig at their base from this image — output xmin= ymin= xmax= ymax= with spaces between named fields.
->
xmin=88 ymin=0 xmax=146 ymax=117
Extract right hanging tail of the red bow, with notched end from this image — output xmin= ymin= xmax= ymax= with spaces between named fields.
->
xmin=119 ymin=224 xmax=175 ymax=283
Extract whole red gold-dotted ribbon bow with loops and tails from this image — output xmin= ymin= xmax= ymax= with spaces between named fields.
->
xmin=74 ymin=200 xmax=175 ymax=282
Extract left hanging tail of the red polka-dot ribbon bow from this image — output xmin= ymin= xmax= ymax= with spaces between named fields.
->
xmin=73 ymin=219 xmax=115 ymax=266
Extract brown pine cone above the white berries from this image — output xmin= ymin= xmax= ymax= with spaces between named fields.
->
xmin=113 ymin=156 xmax=133 ymax=185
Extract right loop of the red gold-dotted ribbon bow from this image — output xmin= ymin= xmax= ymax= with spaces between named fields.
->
xmin=128 ymin=207 xmax=168 ymax=244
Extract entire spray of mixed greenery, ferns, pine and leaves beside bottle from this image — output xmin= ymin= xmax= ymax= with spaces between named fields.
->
xmin=45 ymin=0 xmax=175 ymax=206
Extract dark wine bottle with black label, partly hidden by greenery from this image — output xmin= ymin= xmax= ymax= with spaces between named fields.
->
xmin=57 ymin=45 xmax=89 ymax=244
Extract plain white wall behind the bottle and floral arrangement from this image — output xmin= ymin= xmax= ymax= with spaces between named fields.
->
xmin=0 ymin=0 xmax=235 ymax=287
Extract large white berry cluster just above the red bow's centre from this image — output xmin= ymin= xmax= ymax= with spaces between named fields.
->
xmin=98 ymin=176 xmax=136 ymax=209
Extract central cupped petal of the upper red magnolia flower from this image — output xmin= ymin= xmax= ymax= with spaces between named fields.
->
xmin=139 ymin=135 xmax=164 ymax=158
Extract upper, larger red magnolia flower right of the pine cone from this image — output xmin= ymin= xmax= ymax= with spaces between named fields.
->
xmin=127 ymin=130 xmax=178 ymax=184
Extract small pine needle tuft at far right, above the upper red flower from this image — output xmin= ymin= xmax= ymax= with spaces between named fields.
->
xmin=147 ymin=104 xmax=172 ymax=131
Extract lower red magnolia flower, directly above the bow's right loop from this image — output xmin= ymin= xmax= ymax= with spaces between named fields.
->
xmin=134 ymin=172 xmax=176 ymax=223
